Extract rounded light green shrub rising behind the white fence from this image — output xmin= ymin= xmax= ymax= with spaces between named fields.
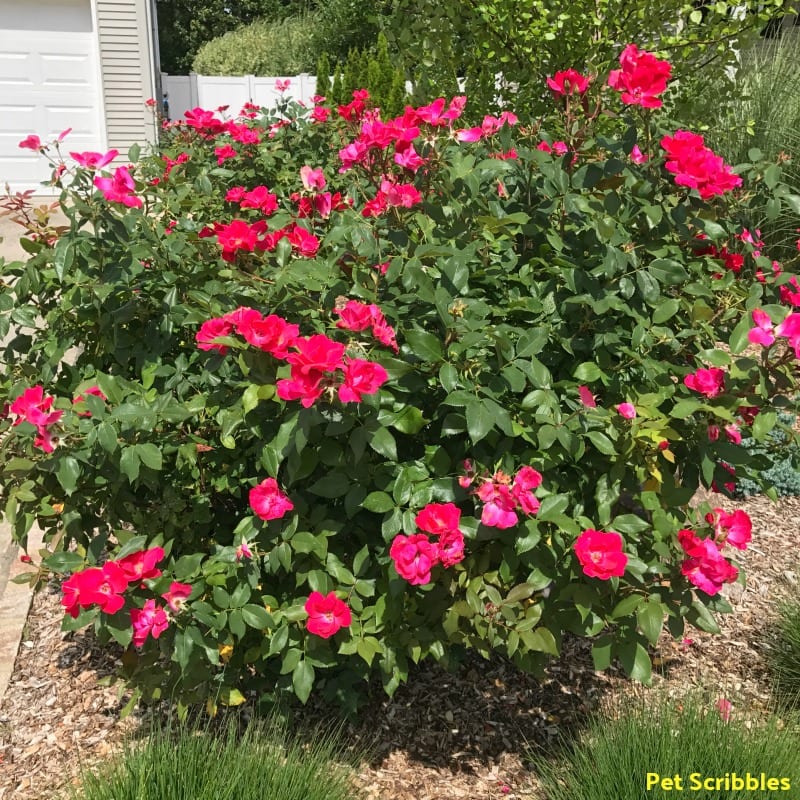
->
xmin=192 ymin=15 xmax=316 ymax=75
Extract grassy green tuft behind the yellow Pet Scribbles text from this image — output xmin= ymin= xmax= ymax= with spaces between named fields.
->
xmin=535 ymin=697 xmax=800 ymax=800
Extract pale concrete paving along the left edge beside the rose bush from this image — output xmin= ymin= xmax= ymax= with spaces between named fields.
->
xmin=0 ymin=197 xmax=63 ymax=699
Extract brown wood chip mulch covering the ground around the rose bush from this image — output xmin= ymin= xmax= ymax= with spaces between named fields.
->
xmin=0 ymin=496 xmax=800 ymax=800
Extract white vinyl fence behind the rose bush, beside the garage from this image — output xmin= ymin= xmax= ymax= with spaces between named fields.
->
xmin=161 ymin=72 xmax=317 ymax=120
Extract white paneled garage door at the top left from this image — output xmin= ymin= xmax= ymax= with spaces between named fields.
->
xmin=0 ymin=0 xmax=104 ymax=191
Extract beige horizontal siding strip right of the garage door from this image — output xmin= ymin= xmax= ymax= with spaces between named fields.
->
xmin=97 ymin=0 xmax=156 ymax=156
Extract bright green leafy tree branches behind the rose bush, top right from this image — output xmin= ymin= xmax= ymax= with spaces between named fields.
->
xmin=386 ymin=0 xmax=786 ymax=116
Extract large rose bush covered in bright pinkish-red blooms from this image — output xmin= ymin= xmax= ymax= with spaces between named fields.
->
xmin=0 ymin=57 xmax=800 ymax=707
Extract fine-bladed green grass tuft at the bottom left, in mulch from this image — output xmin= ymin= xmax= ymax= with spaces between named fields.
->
xmin=71 ymin=720 xmax=360 ymax=800
